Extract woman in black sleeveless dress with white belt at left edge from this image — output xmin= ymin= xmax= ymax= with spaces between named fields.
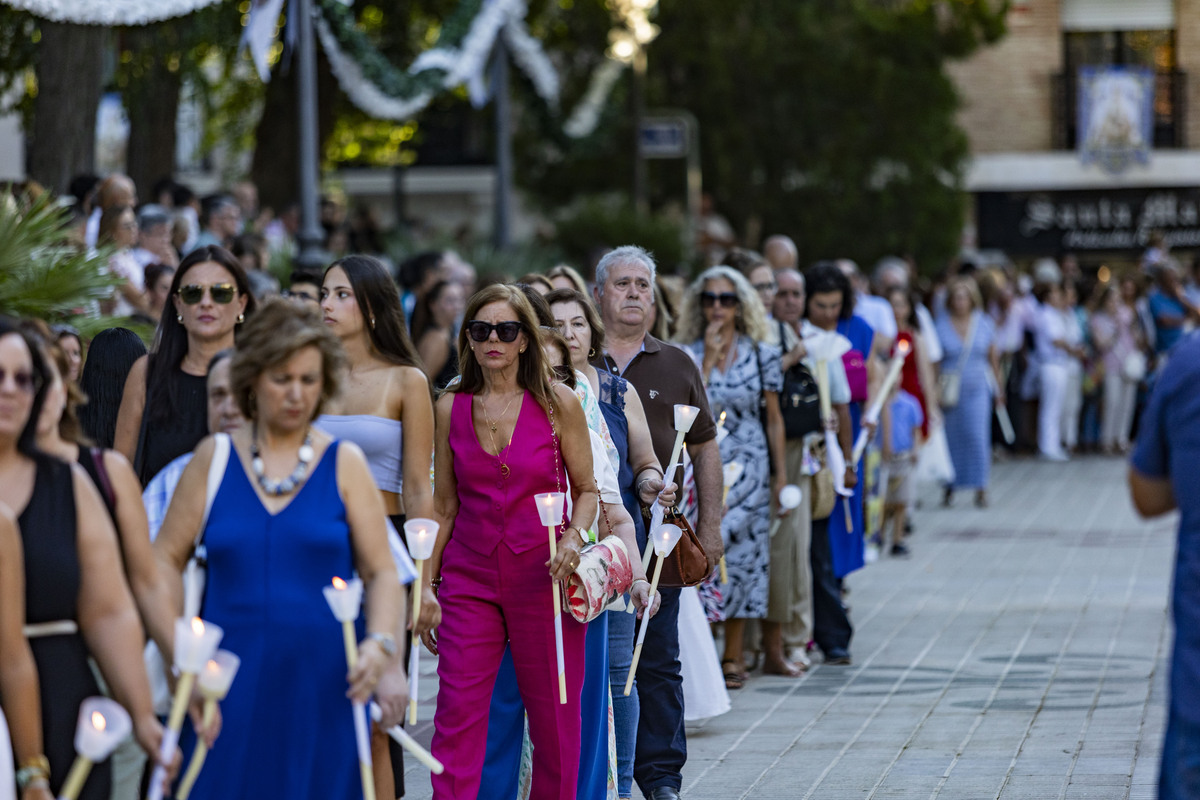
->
xmin=0 ymin=319 xmax=162 ymax=800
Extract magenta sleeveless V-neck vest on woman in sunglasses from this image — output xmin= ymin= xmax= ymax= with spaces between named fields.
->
xmin=450 ymin=392 xmax=566 ymax=558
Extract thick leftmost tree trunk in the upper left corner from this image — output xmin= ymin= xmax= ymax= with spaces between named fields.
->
xmin=28 ymin=22 xmax=109 ymax=192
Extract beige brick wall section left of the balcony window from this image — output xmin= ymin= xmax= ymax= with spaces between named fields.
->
xmin=949 ymin=0 xmax=1060 ymax=154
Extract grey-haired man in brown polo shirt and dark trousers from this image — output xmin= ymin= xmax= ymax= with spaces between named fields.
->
xmin=593 ymin=245 xmax=725 ymax=800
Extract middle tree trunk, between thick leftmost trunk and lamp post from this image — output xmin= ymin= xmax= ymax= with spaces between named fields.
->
xmin=125 ymin=25 xmax=184 ymax=200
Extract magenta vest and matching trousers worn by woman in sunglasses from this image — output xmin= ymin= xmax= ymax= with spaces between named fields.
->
xmin=432 ymin=392 xmax=587 ymax=800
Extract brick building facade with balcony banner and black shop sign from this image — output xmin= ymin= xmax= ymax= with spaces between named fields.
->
xmin=950 ymin=0 xmax=1200 ymax=263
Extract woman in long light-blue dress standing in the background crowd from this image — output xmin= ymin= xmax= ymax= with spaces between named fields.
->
xmin=937 ymin=277 xmax=1004 ymax=509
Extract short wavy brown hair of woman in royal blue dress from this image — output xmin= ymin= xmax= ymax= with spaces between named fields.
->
xmin=229 ymin=297 xmax=347 ymax=422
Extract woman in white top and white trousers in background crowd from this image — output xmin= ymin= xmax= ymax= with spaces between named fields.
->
xmin=1034 ymin=285 xmax=1084 ymax=461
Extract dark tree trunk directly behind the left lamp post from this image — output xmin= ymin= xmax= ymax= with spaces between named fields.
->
xmin=250 ymin=46 xmax=338 ymax=211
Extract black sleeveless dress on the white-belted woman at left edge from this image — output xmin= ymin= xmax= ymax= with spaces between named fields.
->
xmin=19 ymin=456 xmax=112 ymax=800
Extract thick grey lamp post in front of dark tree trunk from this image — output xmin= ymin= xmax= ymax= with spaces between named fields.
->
xmin=294 ymin=0 xmax=325 ymax=270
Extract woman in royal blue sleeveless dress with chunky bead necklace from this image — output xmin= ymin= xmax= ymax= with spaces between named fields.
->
xmin=155 ymin=300 xmax=404 ymax=800
